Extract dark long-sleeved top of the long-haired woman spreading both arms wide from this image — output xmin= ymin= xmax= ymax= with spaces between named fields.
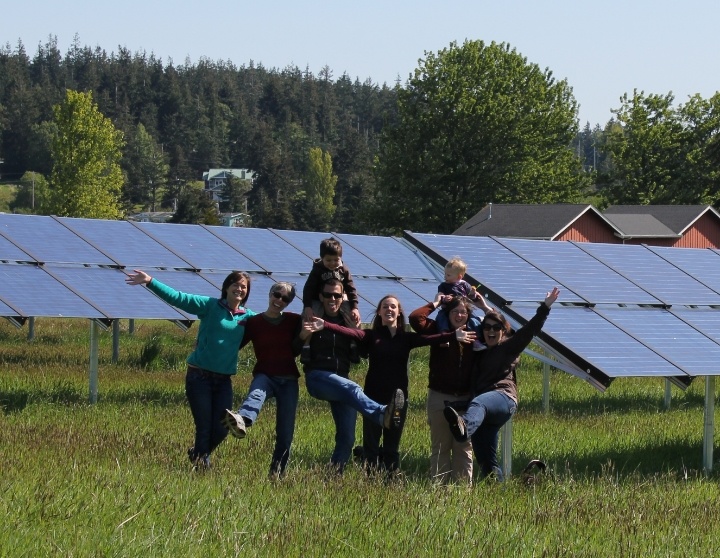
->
xmin=324 ymin=322 xmax=455 ymax=403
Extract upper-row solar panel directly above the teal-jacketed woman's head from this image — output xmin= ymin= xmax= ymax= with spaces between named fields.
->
xmin=137 ymin=223 xmax=264 ymax=271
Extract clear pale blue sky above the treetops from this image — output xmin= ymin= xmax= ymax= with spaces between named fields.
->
xmin=0 ymin=0 xmax=720 ymax=127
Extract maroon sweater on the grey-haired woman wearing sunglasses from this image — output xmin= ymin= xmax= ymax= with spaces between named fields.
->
xmin=240 ymin=312 xmax=302 ymax=378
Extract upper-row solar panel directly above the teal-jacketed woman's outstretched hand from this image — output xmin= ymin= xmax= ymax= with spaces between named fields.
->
xmin=57 ymin=217 xmax=192 ymax=269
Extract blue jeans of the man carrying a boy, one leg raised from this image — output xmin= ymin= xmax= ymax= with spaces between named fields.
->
xmin=305 ymin=370 xmax=385 ymax=471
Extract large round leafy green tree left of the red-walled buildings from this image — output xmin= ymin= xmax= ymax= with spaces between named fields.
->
xmin=377 ymin=41 xmax=587 ymax=232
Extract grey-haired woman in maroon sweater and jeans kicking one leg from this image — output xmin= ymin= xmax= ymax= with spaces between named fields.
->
xmin=223 ymin=282 xmax=302 ymax=476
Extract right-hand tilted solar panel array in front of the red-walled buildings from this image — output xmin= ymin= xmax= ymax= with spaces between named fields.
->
xmin=405 ymin=232 xmax=720 ymax=385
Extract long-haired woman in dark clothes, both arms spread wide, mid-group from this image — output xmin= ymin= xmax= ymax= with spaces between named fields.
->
xmin=306 ymin=295 xmax=475 ymax=472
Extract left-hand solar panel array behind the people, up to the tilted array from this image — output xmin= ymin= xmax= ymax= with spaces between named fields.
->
xmin=0 ymin=214 xmax=439 ymax=328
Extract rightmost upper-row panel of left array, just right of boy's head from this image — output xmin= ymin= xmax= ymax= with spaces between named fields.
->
xmin=335 ymin=234 xmax=442 ymax=280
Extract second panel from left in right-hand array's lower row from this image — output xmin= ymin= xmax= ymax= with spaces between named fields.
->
xmin=596 ymin=308 xmax=720 ymax=376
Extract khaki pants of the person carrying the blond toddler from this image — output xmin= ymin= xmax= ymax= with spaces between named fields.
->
xmin=427 ymin=389 xmax=473 ymax=483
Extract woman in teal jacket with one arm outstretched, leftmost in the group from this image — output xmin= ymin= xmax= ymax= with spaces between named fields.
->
xmin=125 ymin=269 xmax=255 ymax=470
